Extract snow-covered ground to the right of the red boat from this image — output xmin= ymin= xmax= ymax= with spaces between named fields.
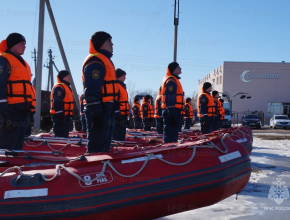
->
xmin=159 ymin=134 xmax=290 ymax=220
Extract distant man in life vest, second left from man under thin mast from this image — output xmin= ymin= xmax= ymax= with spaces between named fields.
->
xmin=141 ymin=95 xmax=154 ymax=131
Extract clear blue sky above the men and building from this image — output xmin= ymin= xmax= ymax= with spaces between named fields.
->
xmin=0 ymin=0 xmax=290 ymax=96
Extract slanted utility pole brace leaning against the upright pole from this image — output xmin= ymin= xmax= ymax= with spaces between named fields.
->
xmin=45 ymin=0 xmax=80 ymax=112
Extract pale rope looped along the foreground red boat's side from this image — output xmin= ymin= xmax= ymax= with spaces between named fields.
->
xmin=0 ymin=133 xmax=229 ymax=183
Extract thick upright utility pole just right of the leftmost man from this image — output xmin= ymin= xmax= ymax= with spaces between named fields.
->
xmin=34 ymin=0 xmax=45 ymax=132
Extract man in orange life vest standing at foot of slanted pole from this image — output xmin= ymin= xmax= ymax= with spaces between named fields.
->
xmin=50 ymin=70 xmax=74 ymax=138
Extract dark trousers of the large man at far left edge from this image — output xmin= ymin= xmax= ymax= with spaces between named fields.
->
xmin=0 ymin=110 xmax=29 ymax=150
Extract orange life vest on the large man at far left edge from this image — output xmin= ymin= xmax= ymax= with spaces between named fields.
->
xmin=0 ymin=53 xmax=33 ymax=104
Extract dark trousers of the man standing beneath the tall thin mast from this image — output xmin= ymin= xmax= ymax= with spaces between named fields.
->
xmin=162 ymin=109 xmax=180 ymax=143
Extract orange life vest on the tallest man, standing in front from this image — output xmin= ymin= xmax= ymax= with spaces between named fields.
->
xmin=82 ymin=40 xmax=119 ymax=102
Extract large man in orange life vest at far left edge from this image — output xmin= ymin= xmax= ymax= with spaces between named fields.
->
xmin=0 ymin=33 xmax=33 ymax=150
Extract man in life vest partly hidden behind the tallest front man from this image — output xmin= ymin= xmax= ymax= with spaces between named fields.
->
xmin=113 ymin=69 xmax=130 ymax=141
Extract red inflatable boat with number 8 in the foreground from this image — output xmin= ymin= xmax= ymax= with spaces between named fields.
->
xmin=0 ymin=134 xmax=251 ymax=220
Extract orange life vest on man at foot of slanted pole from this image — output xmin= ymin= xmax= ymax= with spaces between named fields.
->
xmin=50 ymin=76 xmax=74 ymax=115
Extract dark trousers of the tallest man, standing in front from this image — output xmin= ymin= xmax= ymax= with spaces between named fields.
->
xmin=85 ymin=111 xmax=115 ymax=153
